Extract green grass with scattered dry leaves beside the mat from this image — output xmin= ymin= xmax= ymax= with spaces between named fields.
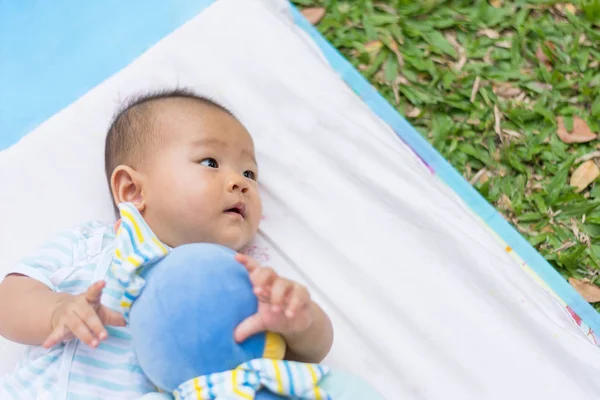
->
xmin=295 ymin=0 xmax=600 ymax=310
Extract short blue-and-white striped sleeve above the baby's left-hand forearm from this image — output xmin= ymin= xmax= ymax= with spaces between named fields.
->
xmin=7 ymin=230 xmax=81 ymax=291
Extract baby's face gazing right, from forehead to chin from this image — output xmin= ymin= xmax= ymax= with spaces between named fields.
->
xmin=143 ymin=100 xmax=262 ymax=250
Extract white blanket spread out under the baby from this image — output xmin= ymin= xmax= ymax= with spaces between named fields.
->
xmin=0 ymin=0 xmax=600 ymax=400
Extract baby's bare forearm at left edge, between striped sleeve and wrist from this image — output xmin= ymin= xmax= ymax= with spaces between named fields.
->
xmin=0 ymin=275 xmax=69 ymax=345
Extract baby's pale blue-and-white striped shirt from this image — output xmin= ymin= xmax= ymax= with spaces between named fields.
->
xmin=0 ymin=222 xmax=155 ymax=400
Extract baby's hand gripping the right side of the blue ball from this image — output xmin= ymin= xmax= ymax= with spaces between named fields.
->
xmin=234 ymin=254 xmax=313 ymax=343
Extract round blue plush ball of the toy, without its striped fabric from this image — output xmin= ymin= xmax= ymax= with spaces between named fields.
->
xmin=129 ymin=243 xmax=285 ymax=400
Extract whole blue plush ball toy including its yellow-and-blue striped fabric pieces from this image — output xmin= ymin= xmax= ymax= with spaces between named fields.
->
xmin=111 ymin=203 xmax=381 ymax=400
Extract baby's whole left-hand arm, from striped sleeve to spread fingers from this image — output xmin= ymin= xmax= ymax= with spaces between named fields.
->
xmin=0 ymin=225 xmax=125 ymax=347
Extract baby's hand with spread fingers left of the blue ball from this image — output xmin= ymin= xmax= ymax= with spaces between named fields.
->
xmin=42 ymin=281 xmax=125 ymax=349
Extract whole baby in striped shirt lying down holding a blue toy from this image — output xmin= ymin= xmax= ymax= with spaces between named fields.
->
xmin=0 ymin=90 xmax=333 ymax=400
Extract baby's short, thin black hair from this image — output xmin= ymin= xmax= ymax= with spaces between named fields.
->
xmin=104 ymin=88 xmax=233 ymax=210
